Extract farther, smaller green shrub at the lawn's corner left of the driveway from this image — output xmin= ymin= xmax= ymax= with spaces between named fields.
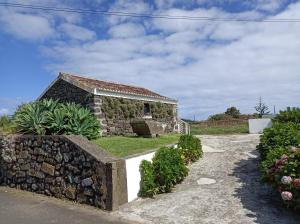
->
xmin=178 ymin=135 xmax=203 ymax=164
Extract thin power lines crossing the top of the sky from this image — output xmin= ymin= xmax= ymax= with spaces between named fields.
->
xmin=0 ymin=2 xmax=300 ymax=23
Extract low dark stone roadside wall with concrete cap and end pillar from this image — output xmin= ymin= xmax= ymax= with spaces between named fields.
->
xmin=0 ymin=135 xmax=127 ymax=210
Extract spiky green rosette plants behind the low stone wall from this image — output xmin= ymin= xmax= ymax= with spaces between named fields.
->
xmin=13 ymin=100 xmax=100 ymax=139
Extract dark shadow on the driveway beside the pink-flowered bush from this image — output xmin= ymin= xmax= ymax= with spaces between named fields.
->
xmin=232 ymin=150 xmax=300 ymax=224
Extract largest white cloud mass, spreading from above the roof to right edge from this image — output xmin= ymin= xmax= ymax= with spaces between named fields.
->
xmin=40 ymin=1 xmax=300 ymax=118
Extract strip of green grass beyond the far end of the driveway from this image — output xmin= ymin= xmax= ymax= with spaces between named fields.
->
xmin=191 ymin=123 xmax=249 ymax=135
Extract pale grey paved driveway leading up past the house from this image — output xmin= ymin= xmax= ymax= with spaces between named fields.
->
xmin=115 ymin=135 xmax=300 ymax=224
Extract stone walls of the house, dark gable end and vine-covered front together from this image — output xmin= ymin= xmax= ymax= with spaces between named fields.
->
xmin=41 ymin=80 xmax=177 ymax=136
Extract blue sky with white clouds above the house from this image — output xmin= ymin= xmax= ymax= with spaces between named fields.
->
xmin=0 ymin=0 xmax=300 ymax=119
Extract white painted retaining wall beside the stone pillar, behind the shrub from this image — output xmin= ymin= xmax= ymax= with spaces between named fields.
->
xmin=125 ymin=152 xmax=155 ymax=202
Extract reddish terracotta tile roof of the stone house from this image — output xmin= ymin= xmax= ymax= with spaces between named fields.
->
xmin=60 ymin=73 xmax=172 ymax=100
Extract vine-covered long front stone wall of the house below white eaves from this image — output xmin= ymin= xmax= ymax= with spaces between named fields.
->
xmin=94 ymin=96 xmax=177 ymax=135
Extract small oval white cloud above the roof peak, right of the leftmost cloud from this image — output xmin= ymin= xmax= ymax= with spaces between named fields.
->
xmin=58 ymin=23 xmax=96 ymax=41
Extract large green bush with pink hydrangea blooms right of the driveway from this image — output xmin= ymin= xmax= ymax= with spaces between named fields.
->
xmin=257 ymin=108 xmax=300 ymax=209
